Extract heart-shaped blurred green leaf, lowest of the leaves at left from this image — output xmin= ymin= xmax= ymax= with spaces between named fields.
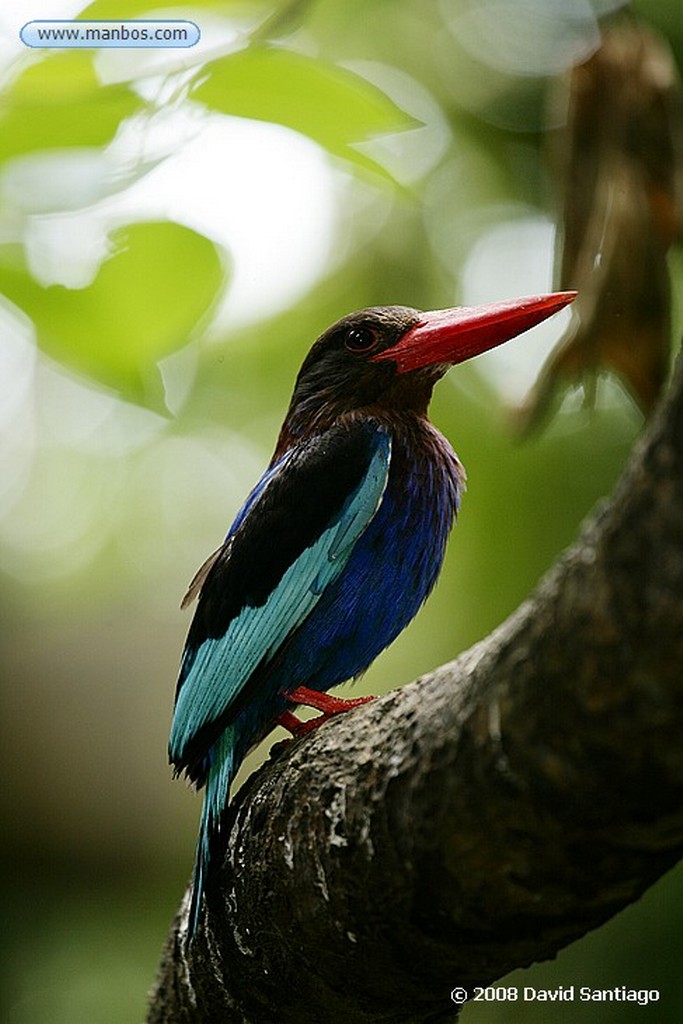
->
xmin=0 ymin=222 xmax=225 ymax=404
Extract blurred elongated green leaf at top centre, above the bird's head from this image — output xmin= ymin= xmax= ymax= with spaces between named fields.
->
xmin=193 ymin=47 xmax=416 ymax=174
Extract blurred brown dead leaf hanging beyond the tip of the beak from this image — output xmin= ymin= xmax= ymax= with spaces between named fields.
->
xmin=519 ymin=16 xmax=683 ymax=430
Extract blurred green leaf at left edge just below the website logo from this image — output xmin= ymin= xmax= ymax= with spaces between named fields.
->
xmin=0 ymin=50 xmax=144 ymax=160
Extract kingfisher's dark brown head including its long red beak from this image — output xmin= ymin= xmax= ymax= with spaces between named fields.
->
xmin=284 ymin=292 xmax=575 ymax=438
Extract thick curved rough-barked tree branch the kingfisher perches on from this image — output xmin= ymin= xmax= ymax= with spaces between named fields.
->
xmin=147 ymin=364 xmax=683 ymax=1024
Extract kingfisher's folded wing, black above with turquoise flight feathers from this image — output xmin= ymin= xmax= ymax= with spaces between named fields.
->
xmin=169 ymin=424 xmax=391 ymax=778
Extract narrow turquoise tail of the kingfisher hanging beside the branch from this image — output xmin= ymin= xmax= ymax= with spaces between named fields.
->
xmin=185 ymin=725 xmax=236 ymax=945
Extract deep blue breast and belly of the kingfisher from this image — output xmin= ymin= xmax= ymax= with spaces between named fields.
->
xmin=276 ymin=419 xmax=464 ymax=708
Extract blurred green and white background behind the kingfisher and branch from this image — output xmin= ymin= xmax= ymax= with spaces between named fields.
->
xmin=0 ymin=0 xmax=683 ymax=1024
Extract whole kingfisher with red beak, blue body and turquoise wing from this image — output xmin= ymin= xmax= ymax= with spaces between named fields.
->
xmin=169 ymin=292 xmax=575 ymax=942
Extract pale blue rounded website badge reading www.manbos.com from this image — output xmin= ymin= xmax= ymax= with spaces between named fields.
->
xmin=19 ymin=20 xmax=201 ymax=48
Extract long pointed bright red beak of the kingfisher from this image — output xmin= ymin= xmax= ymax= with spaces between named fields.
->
xmin=373 ymin=292 xmax=577 ymax=374
